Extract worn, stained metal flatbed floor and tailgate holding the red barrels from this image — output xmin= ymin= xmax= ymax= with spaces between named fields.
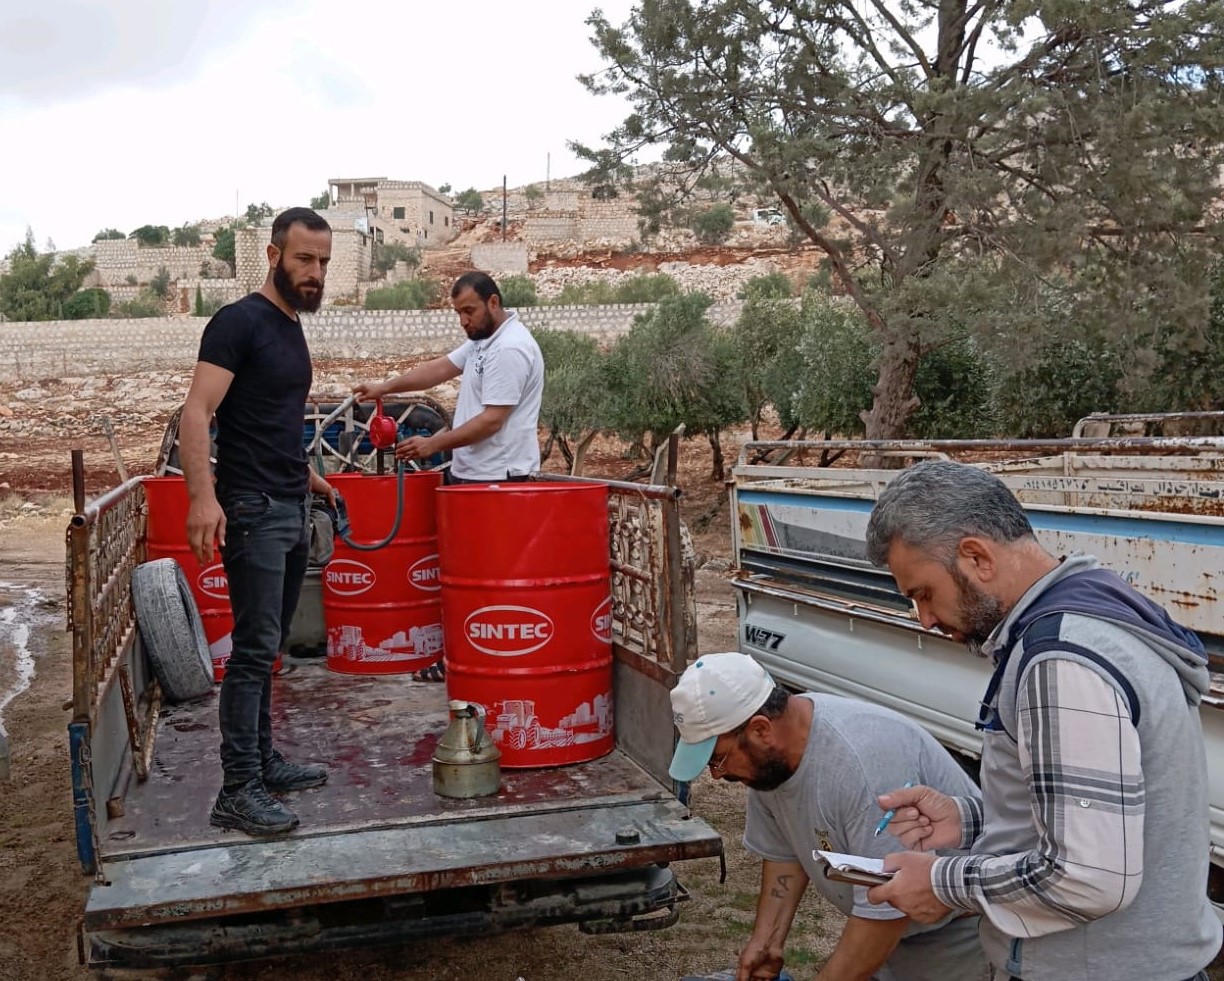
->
xmin=83 ymin=659 xmax=721 ymax=931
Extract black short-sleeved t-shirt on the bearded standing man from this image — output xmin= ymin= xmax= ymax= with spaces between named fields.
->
xmin=200 ymin=293 xmax=313 ymax=497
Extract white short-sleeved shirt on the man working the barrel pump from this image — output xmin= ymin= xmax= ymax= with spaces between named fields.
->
xmin=447 ymin=311 xmax=543 ymax=480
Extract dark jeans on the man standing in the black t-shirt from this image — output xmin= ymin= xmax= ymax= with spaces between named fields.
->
xmin=218 ymin=489 xmax=310 ymax=786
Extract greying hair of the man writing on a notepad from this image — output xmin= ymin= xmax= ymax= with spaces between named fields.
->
xmin=867 ymin=460 xmax=1034 ymax=566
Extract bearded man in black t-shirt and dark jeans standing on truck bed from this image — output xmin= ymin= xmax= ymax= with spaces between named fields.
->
xmin=179 ymin=208 xmax=335 ymax=834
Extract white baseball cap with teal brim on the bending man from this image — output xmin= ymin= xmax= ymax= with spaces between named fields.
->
xmin=667 ymin=652 xmax=775 ymax=783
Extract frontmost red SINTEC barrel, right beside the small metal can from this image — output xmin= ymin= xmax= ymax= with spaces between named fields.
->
xmin=437 ymin=483 xmax=616 ymax=768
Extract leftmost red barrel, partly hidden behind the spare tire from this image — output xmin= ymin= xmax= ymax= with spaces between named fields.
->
xmin=143 ymin=476 xmax=238 ymax=681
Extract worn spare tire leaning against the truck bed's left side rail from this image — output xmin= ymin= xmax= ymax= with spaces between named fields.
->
xmin=132 ymin=558 xmax=213 ymax=702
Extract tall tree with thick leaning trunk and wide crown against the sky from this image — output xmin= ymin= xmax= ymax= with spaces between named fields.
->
xmin=577 ymin=0 xmax=1224 ymax=437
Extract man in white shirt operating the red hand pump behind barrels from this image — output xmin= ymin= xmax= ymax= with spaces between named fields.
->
xmin=353 ymin=272 xmax=543 ymax=484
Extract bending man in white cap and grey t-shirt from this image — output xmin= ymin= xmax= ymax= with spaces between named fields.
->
xmin=671 ymin=653 xmax=989 ymax=981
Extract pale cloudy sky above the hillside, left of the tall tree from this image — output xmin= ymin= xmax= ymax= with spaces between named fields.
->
xmin=0 ymin=0 xmax=633 ymax=255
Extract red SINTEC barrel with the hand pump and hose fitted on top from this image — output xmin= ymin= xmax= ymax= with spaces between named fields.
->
xmin=323 ymin=472 xmax=442 ymax=675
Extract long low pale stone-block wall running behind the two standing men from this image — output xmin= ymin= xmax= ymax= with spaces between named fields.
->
xmin=0 ymin=303 xmax=741 ymax=381
